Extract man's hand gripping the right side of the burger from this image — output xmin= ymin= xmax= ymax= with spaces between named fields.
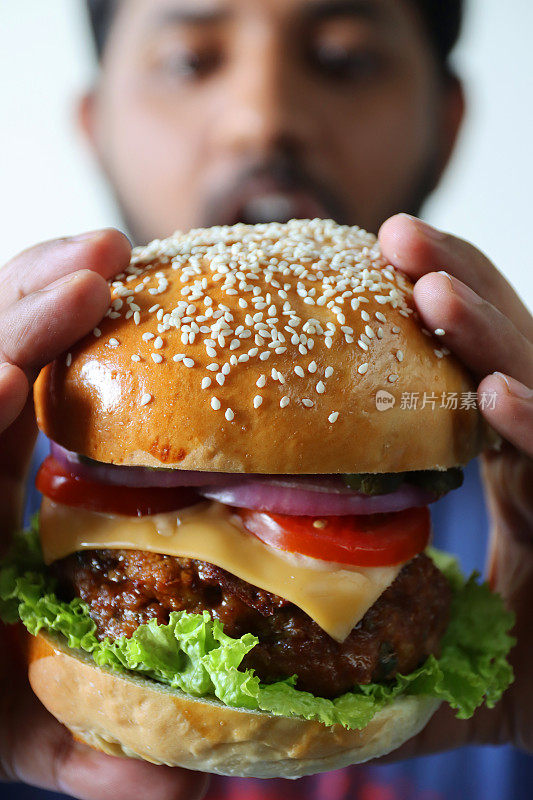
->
xmin=379 ymin=214 xmax=533 ymax=759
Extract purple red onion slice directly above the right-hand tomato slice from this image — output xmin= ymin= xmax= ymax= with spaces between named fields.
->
xmin=199 ymin=480 xmax=437 ymax=517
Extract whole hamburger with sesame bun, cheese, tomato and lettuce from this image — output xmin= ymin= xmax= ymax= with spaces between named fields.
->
xmin=0 ymin=219 xmax=512 ymax=778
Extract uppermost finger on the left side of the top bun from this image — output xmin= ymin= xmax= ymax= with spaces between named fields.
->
xmin=0 ymin=228 xmax=131 ymax=310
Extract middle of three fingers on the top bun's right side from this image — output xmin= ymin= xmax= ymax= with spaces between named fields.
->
xmin=414 ymin=272 xmax=533 ymax=385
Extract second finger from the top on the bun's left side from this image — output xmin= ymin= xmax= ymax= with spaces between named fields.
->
xmin=0 ymin=270 xmax=110 ymax=371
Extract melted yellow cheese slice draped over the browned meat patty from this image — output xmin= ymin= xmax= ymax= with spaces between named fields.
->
xmin=40 ymin=498 xmax=403 ymax=642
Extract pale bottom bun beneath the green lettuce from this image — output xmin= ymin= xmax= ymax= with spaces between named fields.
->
xmin=29 ymin=634 xmax=439 ymax=778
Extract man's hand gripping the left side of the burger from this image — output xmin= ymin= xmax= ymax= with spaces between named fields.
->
xmin=0 ymin=230 xmax=207 ymax=800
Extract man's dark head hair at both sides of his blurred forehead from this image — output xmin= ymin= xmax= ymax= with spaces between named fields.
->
xmin=85 ymin=0 xmax=464 ymax=69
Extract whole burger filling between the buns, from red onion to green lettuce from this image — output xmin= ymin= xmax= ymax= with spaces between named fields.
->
xmin=0 ymin=453 xmax=513 ymax=729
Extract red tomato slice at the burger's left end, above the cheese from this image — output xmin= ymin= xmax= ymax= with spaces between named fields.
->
xmin=35 ymin=456 xmax=202 ymax=517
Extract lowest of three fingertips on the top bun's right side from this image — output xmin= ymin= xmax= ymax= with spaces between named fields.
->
xmin=478 ymin=372 xmax=533 ymax=456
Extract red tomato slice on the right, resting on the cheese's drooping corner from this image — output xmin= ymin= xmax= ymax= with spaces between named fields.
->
xmin=239 ymin=507 xmax=430 ymax=567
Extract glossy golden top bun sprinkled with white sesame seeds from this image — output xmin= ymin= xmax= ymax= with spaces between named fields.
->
xmin=35 ymin=219 xmax=494 ymax=474
